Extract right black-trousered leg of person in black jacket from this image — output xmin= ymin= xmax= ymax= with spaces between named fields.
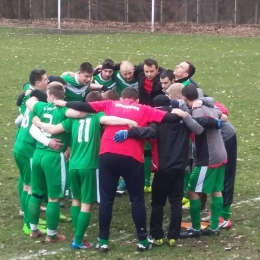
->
xmin=167 ymin=169 xmax=185 ymax=246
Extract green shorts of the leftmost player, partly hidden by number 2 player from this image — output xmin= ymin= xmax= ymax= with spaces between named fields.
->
xmin=14 ymin=152 xmax=32 ymax=185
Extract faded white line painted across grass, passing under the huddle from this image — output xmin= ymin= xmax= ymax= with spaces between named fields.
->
xmin=9 ymin=197 xmax=260 ymax=260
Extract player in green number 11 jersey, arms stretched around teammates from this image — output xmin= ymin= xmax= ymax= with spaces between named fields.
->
xmin=34 ymin=91 xmax=136 ymax=249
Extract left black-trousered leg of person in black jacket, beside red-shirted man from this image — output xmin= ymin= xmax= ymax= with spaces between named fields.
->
xmin=150 ymin=172 xmax=169 ymax=245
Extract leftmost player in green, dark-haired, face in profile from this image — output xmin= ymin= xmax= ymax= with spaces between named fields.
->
xmin=13 ymin=69 xmax=48 ymax=234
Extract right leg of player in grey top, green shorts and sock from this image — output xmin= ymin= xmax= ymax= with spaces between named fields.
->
xmin=202 ymin=165 xmax=225 ymax=235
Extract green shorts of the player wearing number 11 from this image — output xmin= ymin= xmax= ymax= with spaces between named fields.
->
xmin=70 ymin=169 xmax=98 ymax=204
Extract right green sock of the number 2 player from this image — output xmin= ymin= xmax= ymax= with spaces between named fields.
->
xmin=46 ymin=201 xmax=60 ymax=230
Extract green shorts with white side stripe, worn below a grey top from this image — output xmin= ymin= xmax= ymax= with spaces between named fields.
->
xmin=187 ymin=165 xmax=225 ymax=194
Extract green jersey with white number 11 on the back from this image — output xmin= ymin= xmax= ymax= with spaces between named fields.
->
xmin=62 ymin=112 xmax=105 ymax=170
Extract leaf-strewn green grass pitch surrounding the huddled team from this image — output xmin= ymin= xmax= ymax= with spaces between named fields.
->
xmin=0 ymin=28 xmax=260 ymax=260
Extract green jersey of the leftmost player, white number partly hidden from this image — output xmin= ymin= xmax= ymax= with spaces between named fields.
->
xmin=14 ymin=108 xmax=36 ymax=158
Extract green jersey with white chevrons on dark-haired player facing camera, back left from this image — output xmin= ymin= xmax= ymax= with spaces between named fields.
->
xmin=62 ymin=73 xmax=89 ymax=101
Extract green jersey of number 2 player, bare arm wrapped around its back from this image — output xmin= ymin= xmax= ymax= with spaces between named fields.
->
xmin=33 ymin=102 xmax=68 ymax=153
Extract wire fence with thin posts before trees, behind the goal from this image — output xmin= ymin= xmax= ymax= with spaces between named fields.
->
xmin=0 ymin=0 xmax=260 ymax=24
